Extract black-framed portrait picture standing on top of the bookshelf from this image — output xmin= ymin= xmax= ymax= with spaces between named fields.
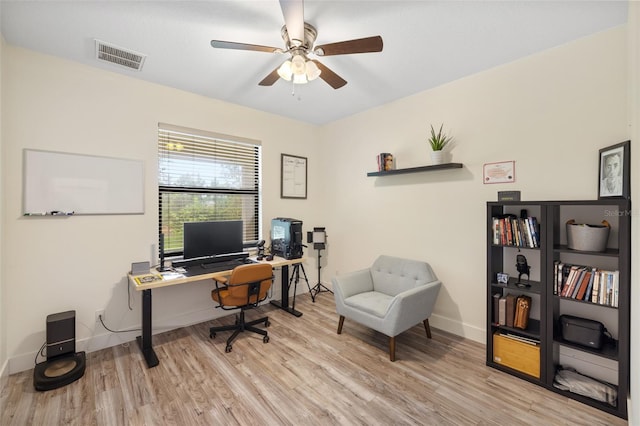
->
xmin=598 ymin=141 xmax=631 ymax=199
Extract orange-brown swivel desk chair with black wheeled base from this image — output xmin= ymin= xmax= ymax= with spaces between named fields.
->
xmin=209 ymin=263 xmax=273 ymax=352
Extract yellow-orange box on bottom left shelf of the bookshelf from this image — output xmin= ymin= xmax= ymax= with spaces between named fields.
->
xmin=493 ymin=333 xmax=540 ymax=379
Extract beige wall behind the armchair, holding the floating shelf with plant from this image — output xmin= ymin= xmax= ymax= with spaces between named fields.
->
xmin=322 ymin=28 xmax=629 ymax=342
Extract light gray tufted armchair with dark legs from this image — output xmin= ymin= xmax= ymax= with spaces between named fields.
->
xmin=332 ymin=256 xmax=441 ymax=361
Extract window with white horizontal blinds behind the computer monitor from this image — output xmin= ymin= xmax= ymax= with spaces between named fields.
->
xmin=158 ymin=124 xmax=261 ymax=256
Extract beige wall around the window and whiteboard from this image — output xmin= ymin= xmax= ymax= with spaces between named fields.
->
xmin=2 ymin=46 xmax=324 ymax=372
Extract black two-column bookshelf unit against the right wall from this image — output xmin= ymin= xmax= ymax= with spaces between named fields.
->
xmin=486 ymin=199 xmax=631 ymax=419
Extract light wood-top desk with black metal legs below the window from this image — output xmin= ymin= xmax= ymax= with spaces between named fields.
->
xmin=129 ymin=257 xmax=305 ymax=368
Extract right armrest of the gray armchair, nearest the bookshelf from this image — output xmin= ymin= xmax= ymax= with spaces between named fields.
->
xmin=385 ymin=280 xmax=442 ymax=335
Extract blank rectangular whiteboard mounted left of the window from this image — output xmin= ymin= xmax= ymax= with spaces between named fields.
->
xmin=23 ymin=149 xmax=144 ymax=215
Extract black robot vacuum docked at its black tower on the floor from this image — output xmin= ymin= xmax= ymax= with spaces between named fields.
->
xmin=33 ymin=311 xmax=86 ymax=391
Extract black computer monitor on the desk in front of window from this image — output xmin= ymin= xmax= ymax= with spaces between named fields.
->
xmin=183 ymin=220 xmax=243 ymax=259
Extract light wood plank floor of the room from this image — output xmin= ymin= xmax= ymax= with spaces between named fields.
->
xmin=0 ymin=293 xmax=626 ymax=426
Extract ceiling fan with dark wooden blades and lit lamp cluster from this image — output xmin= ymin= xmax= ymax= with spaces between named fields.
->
xmin=211 ymin=0 xmax=382 ymax=89
